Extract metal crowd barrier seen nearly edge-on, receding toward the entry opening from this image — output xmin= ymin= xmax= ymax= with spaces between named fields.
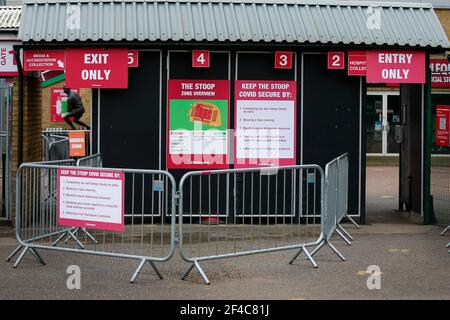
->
xmin=311 ymin=153 xmax=359 ymax=261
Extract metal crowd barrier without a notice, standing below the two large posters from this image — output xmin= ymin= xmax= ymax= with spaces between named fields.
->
xmin=179 ymin=165 xmax=324 ymax=284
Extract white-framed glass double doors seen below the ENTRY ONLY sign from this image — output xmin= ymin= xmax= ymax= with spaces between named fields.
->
xmin=366 ymin=91 xmax=401 ymax=156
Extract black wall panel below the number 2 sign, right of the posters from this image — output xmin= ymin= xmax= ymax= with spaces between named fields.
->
xmin=303 ymin=54 xmax=365 ymax=214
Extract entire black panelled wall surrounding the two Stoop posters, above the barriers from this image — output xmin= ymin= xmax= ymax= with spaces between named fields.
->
xmin=92 ymin=51 xmax=365 ymax=219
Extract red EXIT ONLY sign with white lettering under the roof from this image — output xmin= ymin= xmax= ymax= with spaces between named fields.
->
xmin=66 ymin=48 xmax=128 ymax=88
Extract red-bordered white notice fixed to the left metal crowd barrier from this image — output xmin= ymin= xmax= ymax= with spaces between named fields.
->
xmin=58 ymin=168 xmax=124 ymax=232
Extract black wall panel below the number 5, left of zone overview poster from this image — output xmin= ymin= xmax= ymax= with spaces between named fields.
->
xmin=92 ymin=51 xmax=164 ymax=169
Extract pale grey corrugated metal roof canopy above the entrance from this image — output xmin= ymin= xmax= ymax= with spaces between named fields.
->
xmin=18 ymin=0 xmax=450 ymax=48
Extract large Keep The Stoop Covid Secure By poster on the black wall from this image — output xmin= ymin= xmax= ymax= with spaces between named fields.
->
xmin=234 ymin=80 xmax=297 ymax=168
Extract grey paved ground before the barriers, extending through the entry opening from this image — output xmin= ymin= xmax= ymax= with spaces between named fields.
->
xmin=0 ymin=167 xmax=450 ymax=299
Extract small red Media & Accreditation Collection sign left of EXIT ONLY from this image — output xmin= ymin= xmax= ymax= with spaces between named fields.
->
xmin=23 ymin=50 xmax=66 ymax=71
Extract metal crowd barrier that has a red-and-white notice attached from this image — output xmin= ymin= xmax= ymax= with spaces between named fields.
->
xmin=8 ymin=163 xmax=176 ymax=282
